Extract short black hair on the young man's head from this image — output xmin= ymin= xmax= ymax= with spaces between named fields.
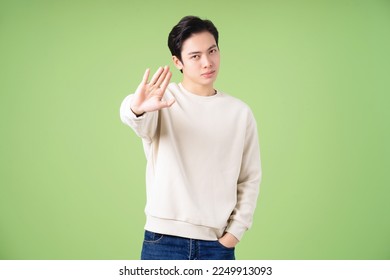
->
xmin=168 ymin=16 xmax=218 ymax=61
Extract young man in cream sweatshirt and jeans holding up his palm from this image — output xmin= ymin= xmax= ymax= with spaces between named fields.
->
xmin=120 ymin=16 xmax=261 ymax=260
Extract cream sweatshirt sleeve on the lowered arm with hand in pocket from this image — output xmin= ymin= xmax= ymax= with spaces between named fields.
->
xmin=226 ymin=110 xmax=262 ymax=240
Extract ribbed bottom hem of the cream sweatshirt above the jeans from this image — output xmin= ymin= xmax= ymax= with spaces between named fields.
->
xmin=145 ymin=216 xmax=225 ymax=241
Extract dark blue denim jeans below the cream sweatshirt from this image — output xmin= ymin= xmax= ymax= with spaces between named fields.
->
xmin=141 ymin=230 xmax=235 ymax=260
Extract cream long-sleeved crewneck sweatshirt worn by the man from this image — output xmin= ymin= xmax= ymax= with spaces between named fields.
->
xmin=120 ymin=83 xmax=261 ymax=240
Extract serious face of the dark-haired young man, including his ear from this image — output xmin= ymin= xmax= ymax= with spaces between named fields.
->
xmin=173 ymin=31 xmax=220 ymax=86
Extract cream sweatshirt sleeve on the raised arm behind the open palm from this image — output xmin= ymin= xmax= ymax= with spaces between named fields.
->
xmin=120 ymin=94 xmax=158 ymax=143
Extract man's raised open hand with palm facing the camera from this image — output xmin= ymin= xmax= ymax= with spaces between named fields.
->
xmin=131 ymin=66 xmax=175 ymax=116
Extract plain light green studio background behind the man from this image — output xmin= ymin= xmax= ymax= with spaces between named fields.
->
xmin=0 ymin=0 xmax=390 ymax=259
